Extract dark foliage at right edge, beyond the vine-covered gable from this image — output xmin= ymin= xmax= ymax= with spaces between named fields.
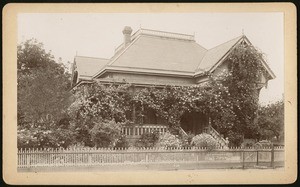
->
xmin=257 ymin=101 xmax=284 ymax=141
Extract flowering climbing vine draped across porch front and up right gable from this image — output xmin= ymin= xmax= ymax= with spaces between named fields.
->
xmin=69 ymin=45 xmax=265 ymax=145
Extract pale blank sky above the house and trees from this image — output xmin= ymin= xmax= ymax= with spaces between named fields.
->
xmin=18 ymin=12 xmax=284 ymax=105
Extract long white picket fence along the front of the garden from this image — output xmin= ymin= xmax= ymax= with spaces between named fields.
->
xmin=18 ymin=147 xmax=284 ymax=168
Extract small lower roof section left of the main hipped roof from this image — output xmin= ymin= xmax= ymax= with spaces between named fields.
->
xmin=74 ymin=56 xmax=109 ymax=78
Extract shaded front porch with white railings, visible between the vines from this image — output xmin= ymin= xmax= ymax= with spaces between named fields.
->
xmin=122 ymin=106 xmax=229 ymax=148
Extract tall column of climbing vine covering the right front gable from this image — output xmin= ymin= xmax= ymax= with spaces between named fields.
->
xmin=212 ymin=44 xmax=267 ymax=145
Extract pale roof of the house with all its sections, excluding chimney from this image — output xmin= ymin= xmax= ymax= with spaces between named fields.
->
xmin=75 ymin=26 xmax=275 ymax=82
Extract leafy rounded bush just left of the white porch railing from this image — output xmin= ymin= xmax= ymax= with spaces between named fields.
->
xmin=89 ymin=119 xmax=121 ymax=148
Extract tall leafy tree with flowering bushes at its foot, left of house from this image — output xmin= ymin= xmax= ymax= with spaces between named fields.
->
xmin=17 ymin=39 xmax=71 ymax=147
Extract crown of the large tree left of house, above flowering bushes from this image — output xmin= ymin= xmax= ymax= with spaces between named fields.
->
xmin=17 ymin=39 xmax=70 ymax=124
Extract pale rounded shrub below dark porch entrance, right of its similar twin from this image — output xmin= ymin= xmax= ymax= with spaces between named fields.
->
xmin=192 ymin=133 xmax=218 ymax=149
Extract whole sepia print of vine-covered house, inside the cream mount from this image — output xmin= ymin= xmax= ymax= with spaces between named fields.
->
xmin=2 ymin=2 xmax=296 ymax=186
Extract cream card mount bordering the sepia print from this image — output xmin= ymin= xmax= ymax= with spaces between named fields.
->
xmin=2 ymin=3 xmax=297 ymax=185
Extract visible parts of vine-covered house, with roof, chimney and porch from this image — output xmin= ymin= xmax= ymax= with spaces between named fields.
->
xmin=72 ymin=26 xmax=275 ymax=146
